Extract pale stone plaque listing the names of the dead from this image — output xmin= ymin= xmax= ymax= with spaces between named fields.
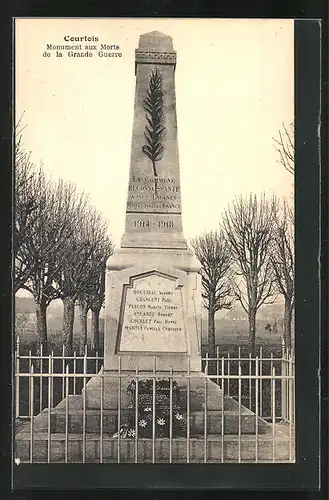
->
xmin=119 ymin=273 xmax=186 ymax=352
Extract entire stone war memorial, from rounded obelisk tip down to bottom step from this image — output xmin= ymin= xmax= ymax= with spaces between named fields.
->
xmin=16 ymin=31 xmax=291 ymax=463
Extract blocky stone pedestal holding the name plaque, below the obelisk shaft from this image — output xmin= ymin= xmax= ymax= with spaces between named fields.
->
xmin=104 ymin=248 xmax=201 ymax=372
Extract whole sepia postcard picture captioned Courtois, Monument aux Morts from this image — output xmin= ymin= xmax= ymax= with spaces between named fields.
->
xmin=13 ymin=18 xmax=296 ymax=466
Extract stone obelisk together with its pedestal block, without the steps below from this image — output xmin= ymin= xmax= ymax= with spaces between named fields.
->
xmin=100 ymin=32 xmax=201 ymax=378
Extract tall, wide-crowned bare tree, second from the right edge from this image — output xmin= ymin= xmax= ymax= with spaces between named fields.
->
xmin=223 ymin=194 xmax=277 ymax=355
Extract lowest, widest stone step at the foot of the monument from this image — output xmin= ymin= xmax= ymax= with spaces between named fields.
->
xmin=15 ymin=433 xmax=294 ymax=463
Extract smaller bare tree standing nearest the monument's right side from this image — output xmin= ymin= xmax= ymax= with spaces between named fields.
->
xmin=191 ymin=231 xmax=232 ymax=357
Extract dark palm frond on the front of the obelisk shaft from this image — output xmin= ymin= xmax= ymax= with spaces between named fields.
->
xmin=142 ymin=68 xmax=166 ymax=184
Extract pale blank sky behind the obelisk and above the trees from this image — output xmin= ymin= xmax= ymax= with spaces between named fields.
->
xmin=16 ymin=18 xmax=294 ymax=250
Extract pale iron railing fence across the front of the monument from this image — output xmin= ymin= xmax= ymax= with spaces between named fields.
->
xmin=15 ymin=342 xmax=295 ymax=463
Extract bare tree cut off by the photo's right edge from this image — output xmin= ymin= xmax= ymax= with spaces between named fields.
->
xmin=271 ymin=198 xmax=295 ymax=349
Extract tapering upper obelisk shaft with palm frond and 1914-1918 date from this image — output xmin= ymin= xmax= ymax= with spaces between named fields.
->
xmin=121 ymin=32 xmax=186 ymax=250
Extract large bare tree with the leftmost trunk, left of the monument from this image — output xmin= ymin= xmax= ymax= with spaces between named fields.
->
xmin=20 ymin=175 xmax=83 ymax=350
